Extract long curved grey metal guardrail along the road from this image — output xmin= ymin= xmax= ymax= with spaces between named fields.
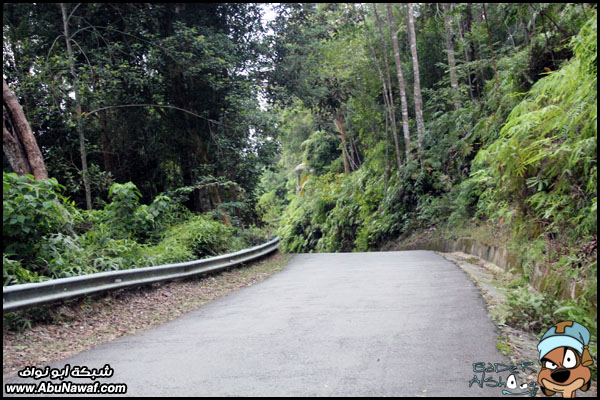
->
xmin=2 ymin=237 xmax=279 ymax=313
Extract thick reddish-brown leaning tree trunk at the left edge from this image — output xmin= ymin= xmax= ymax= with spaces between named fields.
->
xmin=2 ymin=79 xmax=48 ymax=180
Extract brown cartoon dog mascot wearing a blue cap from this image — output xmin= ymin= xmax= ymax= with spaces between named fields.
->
xmin=538 ymin=321 xmax=593 ymax=398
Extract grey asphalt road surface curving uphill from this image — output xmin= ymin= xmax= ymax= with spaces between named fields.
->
xmin=4 ymin=251 xmax=509 ymax=397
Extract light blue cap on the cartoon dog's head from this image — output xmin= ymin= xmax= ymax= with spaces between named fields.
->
xmin=538 ymin=321 xmax=590 ymax=365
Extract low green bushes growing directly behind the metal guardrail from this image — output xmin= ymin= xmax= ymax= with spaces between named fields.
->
xmin=3 ymin=173 xmax=263 ymax=285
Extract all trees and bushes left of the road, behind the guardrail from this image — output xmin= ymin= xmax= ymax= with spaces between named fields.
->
xmin=3 ymin=3 xmax=277 ymax=286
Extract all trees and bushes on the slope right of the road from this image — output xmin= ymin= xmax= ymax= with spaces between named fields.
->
xmin=253 ymin=4 xmax=597 ymax=368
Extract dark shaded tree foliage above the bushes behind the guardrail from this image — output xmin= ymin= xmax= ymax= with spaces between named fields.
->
xmin=3 ymin=3 xmax=276 ymax=217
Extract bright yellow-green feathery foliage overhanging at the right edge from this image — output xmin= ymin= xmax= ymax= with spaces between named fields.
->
xmin=477 ymin=13 xmax=597 ymax=241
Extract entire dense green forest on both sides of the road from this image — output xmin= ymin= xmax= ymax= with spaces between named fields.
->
xmin=3 ymin=3 xmax=597 ymax=355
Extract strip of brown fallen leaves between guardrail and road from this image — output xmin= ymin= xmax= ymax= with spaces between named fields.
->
xmin=2 ymin=252 xmax=290 ymax=376
